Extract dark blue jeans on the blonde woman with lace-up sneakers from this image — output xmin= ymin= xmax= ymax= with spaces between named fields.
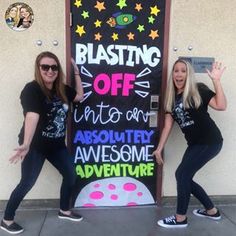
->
xmin=175 ymin=143 xmax=223 ymax=215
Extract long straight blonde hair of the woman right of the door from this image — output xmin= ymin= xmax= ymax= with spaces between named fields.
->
xmin=165 ymin=59 xmax=202 ymax=112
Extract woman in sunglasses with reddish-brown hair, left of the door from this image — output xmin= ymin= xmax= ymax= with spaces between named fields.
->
xmin=1 ymin=52 xmax=84 ymax=234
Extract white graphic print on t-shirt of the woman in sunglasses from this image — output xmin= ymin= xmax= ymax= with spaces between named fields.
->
xmin=42 ymin=101 xmax=68 ymax=138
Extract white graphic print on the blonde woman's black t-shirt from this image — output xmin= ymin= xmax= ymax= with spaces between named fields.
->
xmin=172 ymin=99 xmax=194 ymax=129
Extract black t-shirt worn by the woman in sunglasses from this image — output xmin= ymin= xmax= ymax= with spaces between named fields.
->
xmin=19 ymin=81 xmax=76 ymax=153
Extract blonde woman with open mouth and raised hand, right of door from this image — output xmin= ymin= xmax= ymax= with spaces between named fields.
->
xmin=153 ymin=59 xmax=227 ymax=228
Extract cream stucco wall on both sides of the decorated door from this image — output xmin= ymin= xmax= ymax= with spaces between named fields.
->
xmin=0 ymin=0 xmax=236 ymax=200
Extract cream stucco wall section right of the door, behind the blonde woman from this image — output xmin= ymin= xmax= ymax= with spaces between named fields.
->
xmin=163 ymin=0 xmax=236 ymax=196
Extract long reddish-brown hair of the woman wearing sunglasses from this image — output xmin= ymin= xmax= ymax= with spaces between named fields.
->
xmin=35 ymin=51 xmax=68 ymax=104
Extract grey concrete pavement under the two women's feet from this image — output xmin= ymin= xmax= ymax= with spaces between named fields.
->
xmin=0 ymin=200 xmax=236 ymax=236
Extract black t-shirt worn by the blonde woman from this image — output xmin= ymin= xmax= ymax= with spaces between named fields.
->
xmin=171 ymin=83 xmax=223 ymax=145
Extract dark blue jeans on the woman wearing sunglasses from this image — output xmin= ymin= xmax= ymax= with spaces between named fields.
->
xmin=4 ymin=148 xmax=76 ymax=220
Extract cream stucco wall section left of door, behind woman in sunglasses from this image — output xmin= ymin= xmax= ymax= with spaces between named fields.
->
xmin=0 ymin=0 xmax=65 ymax=200
